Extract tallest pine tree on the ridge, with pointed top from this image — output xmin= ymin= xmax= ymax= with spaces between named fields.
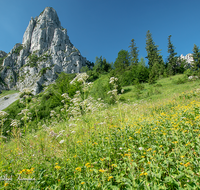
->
xmin=146 ymin=30 xmax=164 ymax=83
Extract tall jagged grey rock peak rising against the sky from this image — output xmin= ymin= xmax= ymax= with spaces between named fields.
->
xmin=1 ymin=7 xmax=92 ymax=94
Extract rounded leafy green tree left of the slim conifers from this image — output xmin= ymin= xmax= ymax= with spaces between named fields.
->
xmin=114 ymin=50 xmax=130 ymax=74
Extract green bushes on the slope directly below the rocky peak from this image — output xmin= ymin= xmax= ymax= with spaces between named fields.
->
xmin=4 ymin=73 xmax=81 ymax=135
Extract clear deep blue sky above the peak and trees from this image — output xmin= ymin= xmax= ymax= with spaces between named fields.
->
xmin=0 ymin=0 xmax=200 ymax=62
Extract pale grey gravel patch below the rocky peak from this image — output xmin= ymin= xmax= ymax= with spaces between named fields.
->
xmin=0 ymin=93 xmax=19 ymax=111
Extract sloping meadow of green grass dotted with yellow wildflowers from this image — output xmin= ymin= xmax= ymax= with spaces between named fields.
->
xmin=0 ymin=75 xmax=200 ymax=190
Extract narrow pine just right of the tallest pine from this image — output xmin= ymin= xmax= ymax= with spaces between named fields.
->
xmin=167 ymin=35 xmax=178 ymax=75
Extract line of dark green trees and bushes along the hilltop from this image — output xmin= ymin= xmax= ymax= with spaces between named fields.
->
xmin=82 ymin=30 xmax=200 ymax=86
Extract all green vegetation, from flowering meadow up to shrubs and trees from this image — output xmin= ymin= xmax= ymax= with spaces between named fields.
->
xmin=0 ymin=28 xmax=200 ymax=190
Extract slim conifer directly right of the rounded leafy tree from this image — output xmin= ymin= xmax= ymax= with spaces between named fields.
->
xmin=129 ymin=39 xmax=139 ymax=66
